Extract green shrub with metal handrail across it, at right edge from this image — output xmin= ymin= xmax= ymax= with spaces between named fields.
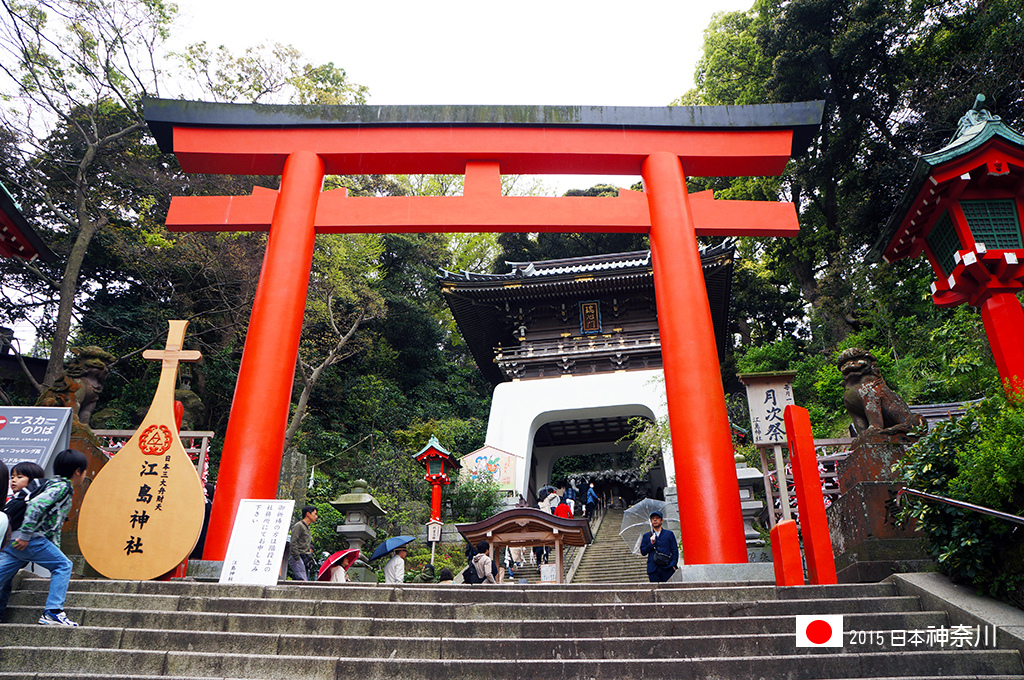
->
xmin=894 ymin=390 xmax=1024 ymax=608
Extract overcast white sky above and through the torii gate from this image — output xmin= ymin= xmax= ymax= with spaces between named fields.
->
xmin=169 ymin=0 xmax=753 ymax=190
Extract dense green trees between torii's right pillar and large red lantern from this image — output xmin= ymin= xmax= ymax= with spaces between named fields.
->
xmin=677 ymin=0 xmax=1024 ymax=436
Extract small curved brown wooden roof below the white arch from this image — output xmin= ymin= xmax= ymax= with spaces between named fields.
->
xmin=456 ymin=508 xmax=594 ymax=548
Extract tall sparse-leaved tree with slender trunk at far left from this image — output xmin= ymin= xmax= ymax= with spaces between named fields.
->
xmin=0 ymin=0 xmax=174 ymax=389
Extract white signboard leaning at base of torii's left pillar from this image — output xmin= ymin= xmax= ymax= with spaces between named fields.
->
xmin=220 ymin=499 xmax=295 ymax=586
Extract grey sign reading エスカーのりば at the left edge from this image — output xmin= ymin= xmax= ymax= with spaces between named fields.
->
xmin=0 ymin=407 xmax=71 ymax=475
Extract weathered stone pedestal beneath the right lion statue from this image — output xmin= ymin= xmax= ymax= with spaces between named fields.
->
xmin=825 ymin=432 xmax=930 ymax=583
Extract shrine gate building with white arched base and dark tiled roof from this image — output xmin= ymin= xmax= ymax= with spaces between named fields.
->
xmin=438 ymin=244 xmax=733 ymax=503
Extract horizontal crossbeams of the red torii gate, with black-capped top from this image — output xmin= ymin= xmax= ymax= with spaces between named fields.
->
xmin=145 ymin=99 xmax=821 ymax=237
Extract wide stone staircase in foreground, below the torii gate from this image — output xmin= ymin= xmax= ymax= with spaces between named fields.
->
xmin=0 ymin=578 xmax=1024 ymax=680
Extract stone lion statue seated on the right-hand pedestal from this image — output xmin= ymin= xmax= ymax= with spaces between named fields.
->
xmin=836 ymin=347 xmax=927 ymax=435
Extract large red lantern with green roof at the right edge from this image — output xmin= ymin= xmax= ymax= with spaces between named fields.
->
xmin=871 ymin=94 xmax=1024 ymax=392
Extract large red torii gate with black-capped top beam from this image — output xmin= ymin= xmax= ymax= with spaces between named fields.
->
xmin=145 ymin=99 xmax=822 ymax=564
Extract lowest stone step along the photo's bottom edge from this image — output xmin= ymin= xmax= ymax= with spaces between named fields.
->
xmin=0 ymin=645 xmax=1021 ymax=680
